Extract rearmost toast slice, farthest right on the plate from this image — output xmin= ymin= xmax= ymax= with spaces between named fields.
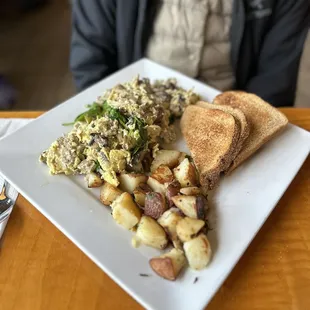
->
xmin=213 ymin=91 xmax=288 ymax=172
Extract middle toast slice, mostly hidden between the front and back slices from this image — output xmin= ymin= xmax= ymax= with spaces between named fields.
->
xmin=196 ymin=101 xmax=250 ymax=159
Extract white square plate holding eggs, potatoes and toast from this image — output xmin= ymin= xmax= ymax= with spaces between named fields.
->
xmin=0 ymin=59 xmax=310 ymax=310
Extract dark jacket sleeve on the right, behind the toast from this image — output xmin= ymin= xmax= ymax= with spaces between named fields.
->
xmin=246 ymin=0 xmax=310 ymax=107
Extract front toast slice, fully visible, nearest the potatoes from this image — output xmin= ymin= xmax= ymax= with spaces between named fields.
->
xmin=181 ymin=105 xmax=240 ymax=189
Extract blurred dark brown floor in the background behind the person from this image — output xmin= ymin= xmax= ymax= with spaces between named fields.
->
xmin=0 ymin=0 xmax=310 ymax=110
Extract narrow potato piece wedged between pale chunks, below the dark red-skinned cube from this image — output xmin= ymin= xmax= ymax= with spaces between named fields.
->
xmin=157 ymin=208 xmax=183 ymax=249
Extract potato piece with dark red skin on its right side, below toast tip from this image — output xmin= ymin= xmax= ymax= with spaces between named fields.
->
xmin=171 ymin=195 xmax=206 ymax=220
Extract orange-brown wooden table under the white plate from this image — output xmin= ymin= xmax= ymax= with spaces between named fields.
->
xmin=0 ymin=109 xmax=310 ymax=310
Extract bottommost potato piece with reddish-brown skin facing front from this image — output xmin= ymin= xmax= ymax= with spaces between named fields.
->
xmin=149 ymin=249 xmax=186 ymax=281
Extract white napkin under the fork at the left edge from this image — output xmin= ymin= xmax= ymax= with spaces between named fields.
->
xmin=0 ymin=118 xmax=31 ymax=239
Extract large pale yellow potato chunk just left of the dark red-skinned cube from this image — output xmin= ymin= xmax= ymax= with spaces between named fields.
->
xmin=111 ymin=192 xmax=141 ymax=229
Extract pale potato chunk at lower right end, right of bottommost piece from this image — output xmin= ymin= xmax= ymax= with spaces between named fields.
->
xmin=184 ymin=234 xmax=212 ymax=270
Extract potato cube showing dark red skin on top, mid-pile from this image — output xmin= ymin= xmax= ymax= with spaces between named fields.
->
xmin=144 ymin=192 xmax=167 ymax=220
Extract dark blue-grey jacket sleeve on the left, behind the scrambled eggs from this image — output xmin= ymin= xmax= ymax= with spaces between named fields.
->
xmin=70 ymin=0 xmax=117 ymax=90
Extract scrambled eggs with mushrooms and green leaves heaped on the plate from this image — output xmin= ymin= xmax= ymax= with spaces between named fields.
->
xmin=40 ymin=77 xmax=199 ymax=186
